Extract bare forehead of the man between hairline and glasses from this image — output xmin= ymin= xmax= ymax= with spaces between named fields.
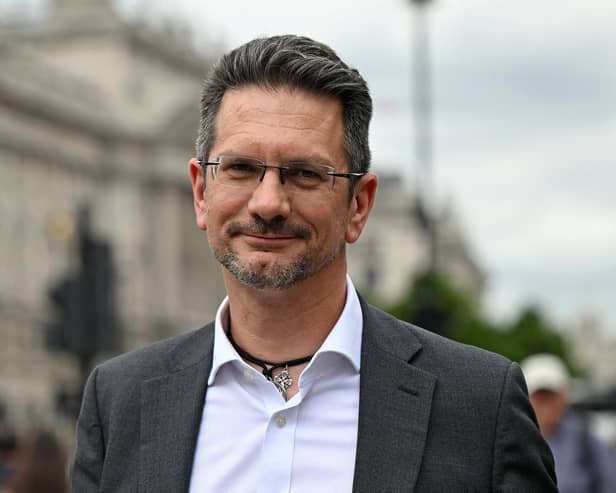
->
xmin=212 ymin=85 xmax=344 ymax=160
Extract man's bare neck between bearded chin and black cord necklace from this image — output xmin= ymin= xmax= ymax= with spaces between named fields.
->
xmin=225 ymin=262 xmax=346 ymax=361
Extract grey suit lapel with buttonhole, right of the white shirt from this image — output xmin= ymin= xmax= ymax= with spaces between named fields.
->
xmin=353 ymin=302 xmax=436 ymax=492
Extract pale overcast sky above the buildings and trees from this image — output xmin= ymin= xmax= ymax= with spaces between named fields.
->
xmin=5 ymin=0 xmax=616 ymax=334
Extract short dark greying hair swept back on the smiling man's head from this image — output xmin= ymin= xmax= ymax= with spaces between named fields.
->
xmin=196 ymin=34 xmax=372 ymax=173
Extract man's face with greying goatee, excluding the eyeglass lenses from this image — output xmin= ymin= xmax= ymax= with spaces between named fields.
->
xmin=191 ymin=86 xmax=376 ymax=289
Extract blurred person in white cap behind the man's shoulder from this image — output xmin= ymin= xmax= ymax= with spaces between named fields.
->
xmin=521 ymin=354 xmax=616 ymax=493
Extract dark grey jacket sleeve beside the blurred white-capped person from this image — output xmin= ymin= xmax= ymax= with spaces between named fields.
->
xmin=492 ymin=363 xmax=558 ymax=493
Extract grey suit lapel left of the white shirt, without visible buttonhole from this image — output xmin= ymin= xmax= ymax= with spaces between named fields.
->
xmin=139 ymin=326 xmax=214 ymax=492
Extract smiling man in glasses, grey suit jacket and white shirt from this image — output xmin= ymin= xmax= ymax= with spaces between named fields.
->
xmin=73 ymin=36 xmax=556 ymax=493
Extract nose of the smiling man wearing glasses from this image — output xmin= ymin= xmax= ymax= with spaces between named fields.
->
xmin=248 ymin=168 xmax=291 ymax=221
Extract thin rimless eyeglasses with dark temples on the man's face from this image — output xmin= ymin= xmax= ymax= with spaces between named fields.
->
xmin=199 ymin=155 xmax=365 ymax=192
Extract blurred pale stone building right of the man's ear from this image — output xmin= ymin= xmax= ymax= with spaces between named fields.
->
xmin=349 ymin=173 xmax=485 ymax=301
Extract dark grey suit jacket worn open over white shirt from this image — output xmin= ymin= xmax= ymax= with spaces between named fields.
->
xmin=72 ymin=302 xmax=557 ymax=493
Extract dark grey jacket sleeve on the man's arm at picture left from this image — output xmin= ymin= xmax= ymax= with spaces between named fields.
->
xmin=71 ymin=369 xmax=105 ymax=493
